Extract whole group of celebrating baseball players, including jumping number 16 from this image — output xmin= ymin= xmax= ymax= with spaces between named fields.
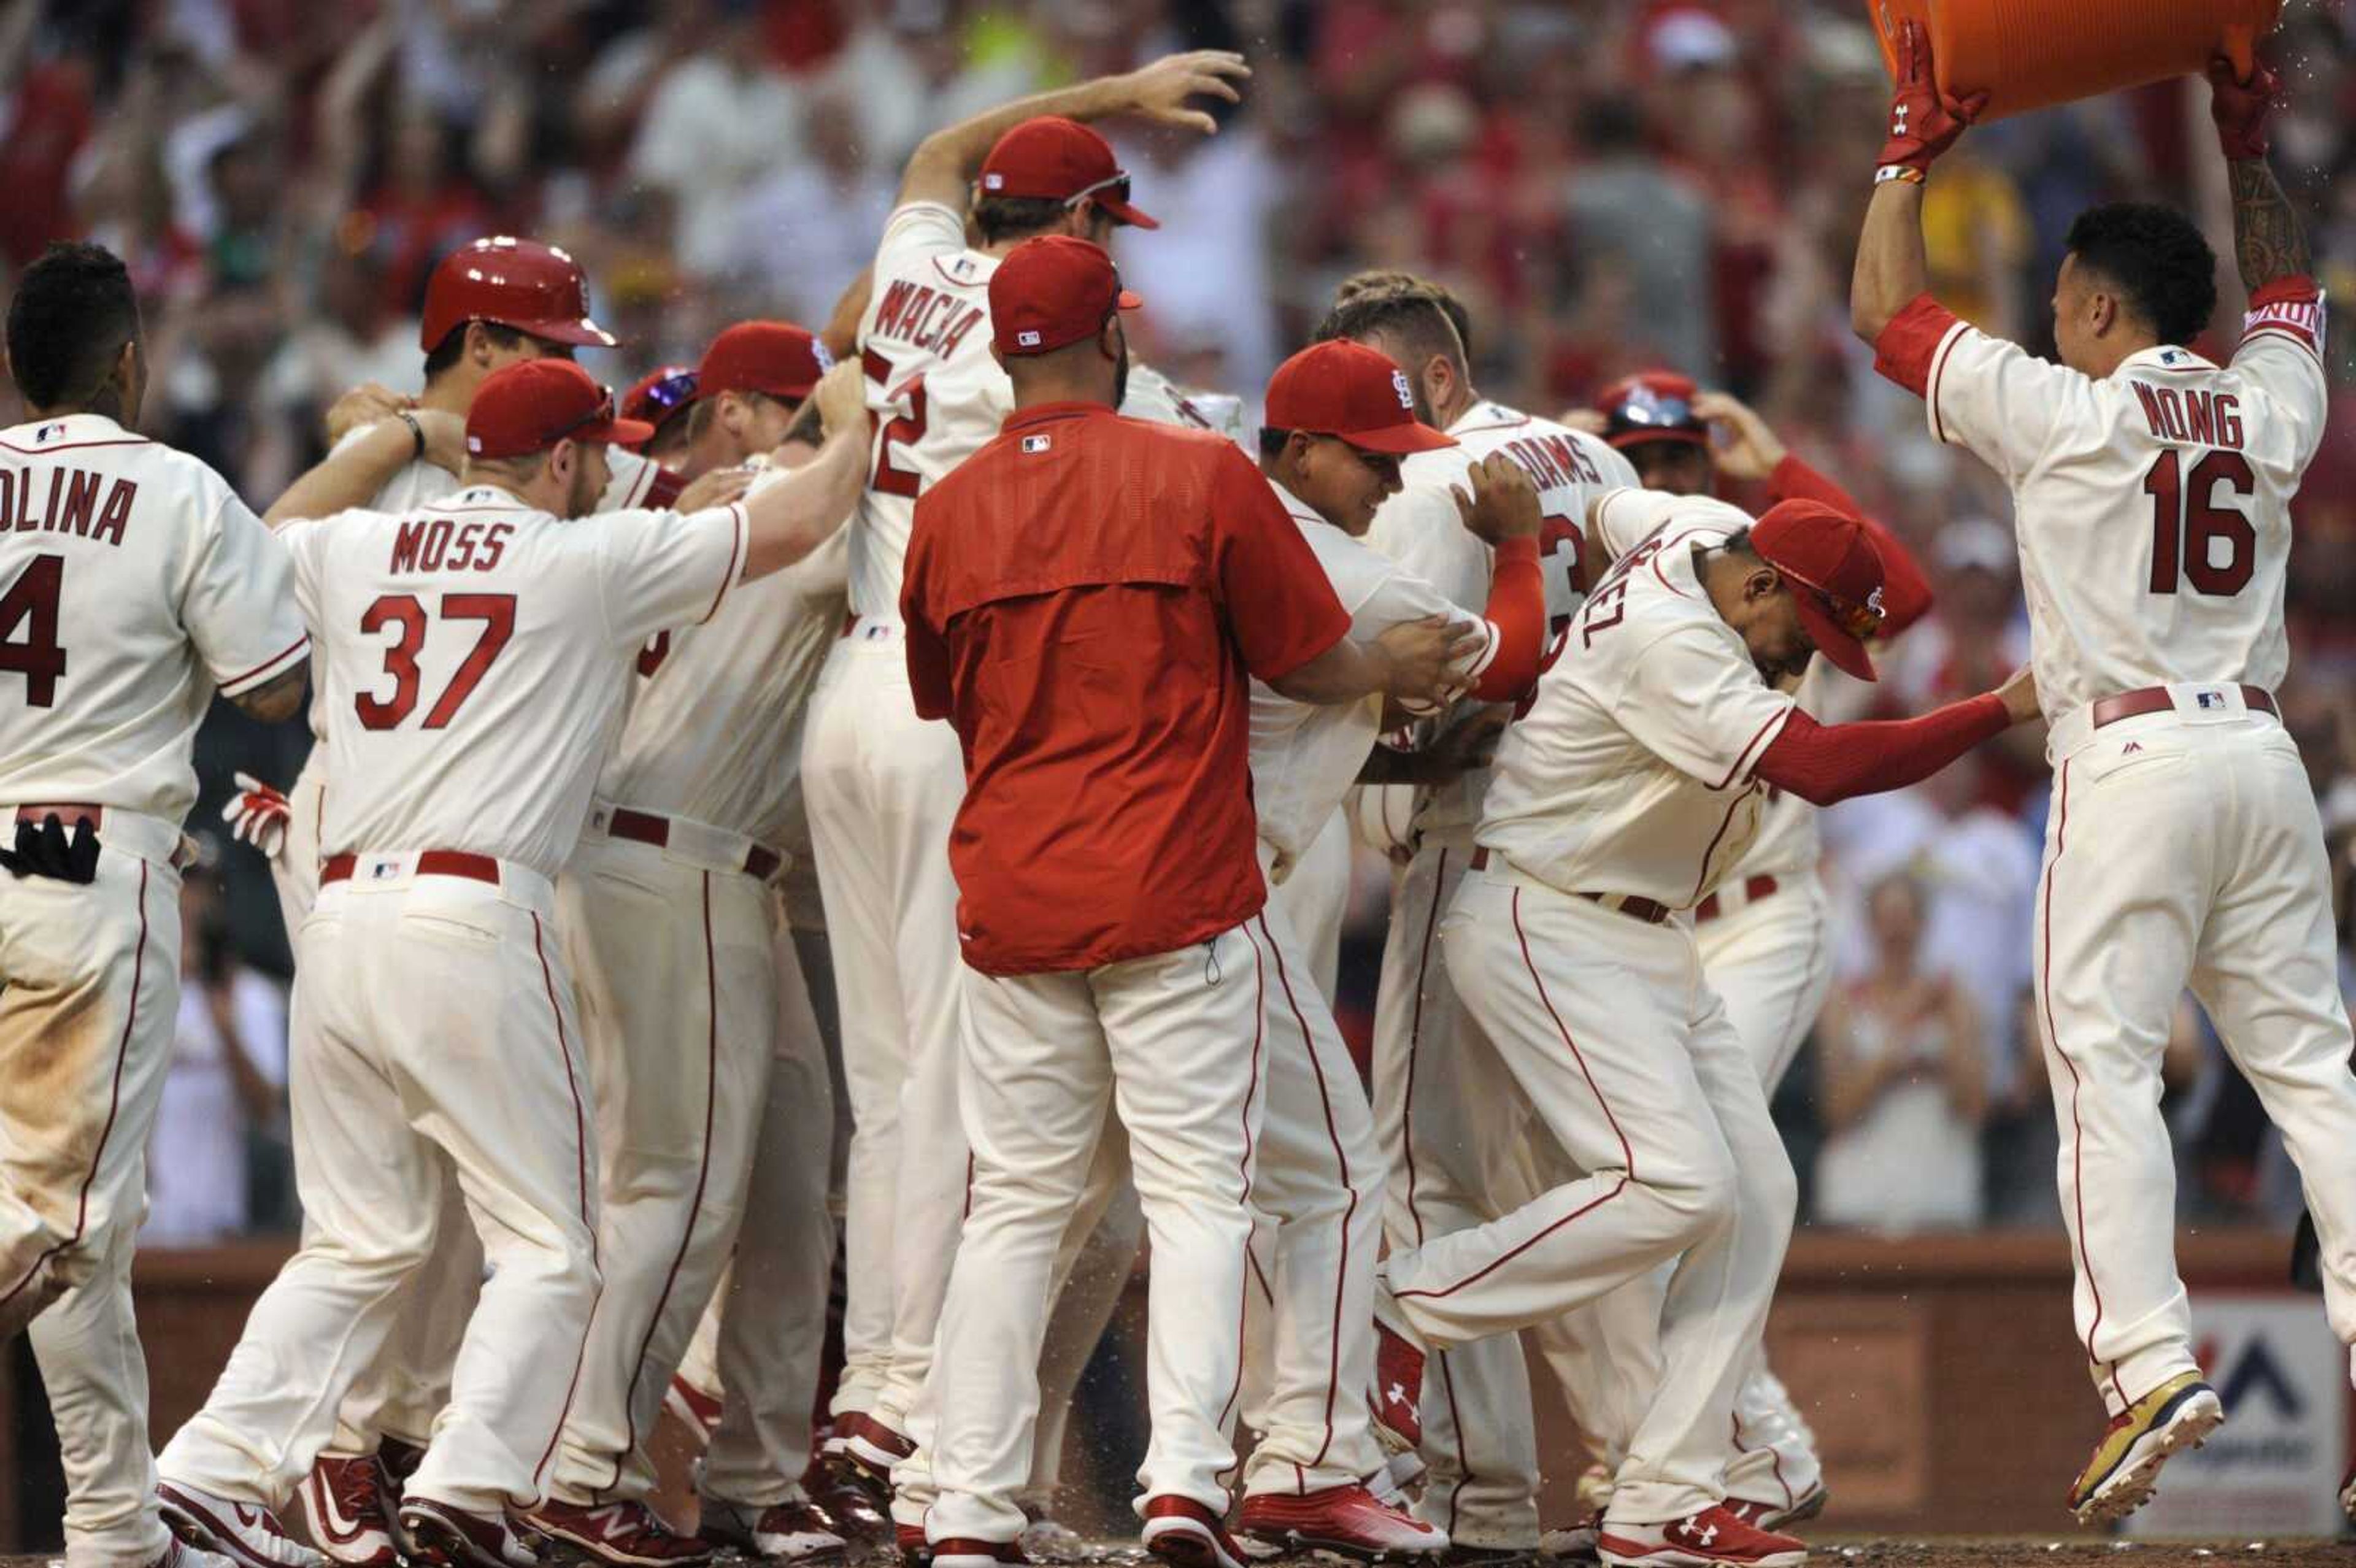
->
xmin=0 ymin=28 xmax=2356 ymax=1568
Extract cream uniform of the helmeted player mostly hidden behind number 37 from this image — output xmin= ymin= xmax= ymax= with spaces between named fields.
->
xmin=285 ymin=433 xmax=664 ymax=1455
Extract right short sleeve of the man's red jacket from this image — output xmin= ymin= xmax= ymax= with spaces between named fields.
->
xmin=1211 ymin=440 xmax=1350 ymax=680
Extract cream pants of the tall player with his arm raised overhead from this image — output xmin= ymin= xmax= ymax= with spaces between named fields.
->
xmin=801 ymin=619 xmax=966 ymax=1431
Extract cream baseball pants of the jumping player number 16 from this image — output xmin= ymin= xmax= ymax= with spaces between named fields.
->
xmin=2036 ymin=688 xmax=2356 ymax=1415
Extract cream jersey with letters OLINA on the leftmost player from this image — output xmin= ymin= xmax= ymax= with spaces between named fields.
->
xmin=0 ymin=414 xmax=306 ymax=821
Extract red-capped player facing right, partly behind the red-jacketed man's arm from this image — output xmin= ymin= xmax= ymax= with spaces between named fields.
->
xmin=1237 ymin=341 xmax=1546 ymax=1559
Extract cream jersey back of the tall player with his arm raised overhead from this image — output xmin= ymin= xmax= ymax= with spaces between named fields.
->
xmin=850 ymin=202 xmax=1013 ymax=619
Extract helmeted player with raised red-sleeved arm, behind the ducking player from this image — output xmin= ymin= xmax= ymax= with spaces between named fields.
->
xmin=1524 ymin=370 xmax=1932 ymax=1545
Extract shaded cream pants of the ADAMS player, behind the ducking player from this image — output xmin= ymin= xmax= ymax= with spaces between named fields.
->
xmin=1374 ymin=843 xmax=1539 ymax=1549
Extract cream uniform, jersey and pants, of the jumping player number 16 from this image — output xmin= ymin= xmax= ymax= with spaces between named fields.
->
xmin=1882 ymin=290 xmax=2356 ymax=1413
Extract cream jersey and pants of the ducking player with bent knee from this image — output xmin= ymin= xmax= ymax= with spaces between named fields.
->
xmin=1385 ymin=490 xmax=1798 ymax=1523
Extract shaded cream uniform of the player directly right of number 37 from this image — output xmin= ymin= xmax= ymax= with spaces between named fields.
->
xmin=552 ymin=471 xmax=846 ymax=1504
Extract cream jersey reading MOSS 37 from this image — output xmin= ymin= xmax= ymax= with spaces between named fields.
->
xmin=285 ymin=485 xmax=744 ymax=876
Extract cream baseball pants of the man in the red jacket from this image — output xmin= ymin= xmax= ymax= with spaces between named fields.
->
xmin=926 ymin=928 xmax=1274 ymax=1542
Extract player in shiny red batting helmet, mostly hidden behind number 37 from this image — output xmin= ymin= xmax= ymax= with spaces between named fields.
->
xmin=224 ymin=236 xmax=699 ymax=1568
